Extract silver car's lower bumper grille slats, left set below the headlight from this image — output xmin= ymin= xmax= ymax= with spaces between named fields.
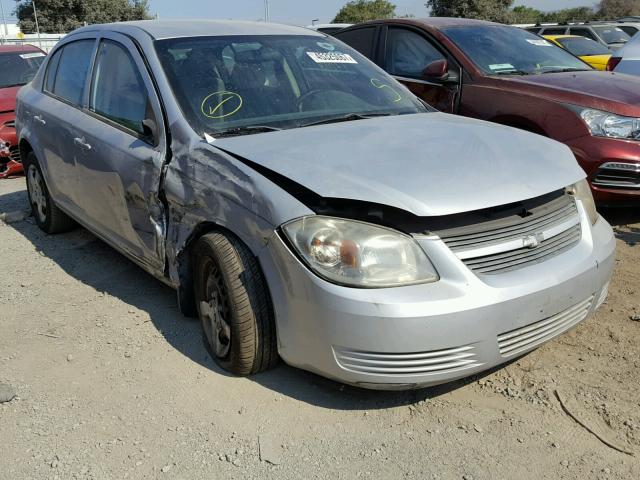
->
xmin=333 ymin=345 xmax=482 ymax=375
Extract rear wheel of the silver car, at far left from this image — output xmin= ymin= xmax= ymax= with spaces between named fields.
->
xmin=24 ymin=152 xmax=76 ymax=233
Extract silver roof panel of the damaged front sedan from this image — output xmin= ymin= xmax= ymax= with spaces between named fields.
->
xmin=73 ymin=20 xmax=324 ymax=40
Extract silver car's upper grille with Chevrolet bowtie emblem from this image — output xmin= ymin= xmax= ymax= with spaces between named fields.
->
xmin=434 ymin=195 xmax=582 ymax=274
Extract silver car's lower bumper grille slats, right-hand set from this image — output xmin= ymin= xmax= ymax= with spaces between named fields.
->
xmin=498 ymin=295 xmax=594 ymax=357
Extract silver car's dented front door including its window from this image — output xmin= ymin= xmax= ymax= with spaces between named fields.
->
xmin=73 ymin=33 xmax=166 ymax=271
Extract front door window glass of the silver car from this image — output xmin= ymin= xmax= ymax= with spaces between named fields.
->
xmin=89 ymin=40 xmax=148 ymax=135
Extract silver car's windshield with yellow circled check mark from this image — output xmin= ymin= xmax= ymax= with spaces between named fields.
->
xmin=156 ymin=35 xmax=430 ymax=136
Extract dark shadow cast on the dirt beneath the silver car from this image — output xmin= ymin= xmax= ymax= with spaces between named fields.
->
xmin=0 ymin=191 xmax=496 ymax=410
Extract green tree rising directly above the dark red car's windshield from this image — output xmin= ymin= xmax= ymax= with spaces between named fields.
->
xmin=425 ymin=0 xmax=514 ymax=22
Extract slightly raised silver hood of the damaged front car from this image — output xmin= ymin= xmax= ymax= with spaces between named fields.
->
xmin=212 ymin=113 xmax=585 ymax=216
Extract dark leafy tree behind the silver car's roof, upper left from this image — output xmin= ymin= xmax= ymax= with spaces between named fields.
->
xmin=15 ymin=0 xmax=151 ymax=33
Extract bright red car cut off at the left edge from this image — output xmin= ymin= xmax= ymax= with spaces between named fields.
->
xmin=0 ymin=45 xmax=45 ymax=178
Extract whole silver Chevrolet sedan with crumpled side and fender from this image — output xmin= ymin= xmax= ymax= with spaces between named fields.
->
xmin=17 ymin=21 xmax=615 ymax=389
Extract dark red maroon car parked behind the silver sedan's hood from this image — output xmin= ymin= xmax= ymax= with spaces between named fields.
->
xmin=335 ymin=18 xmax=640 ymax=205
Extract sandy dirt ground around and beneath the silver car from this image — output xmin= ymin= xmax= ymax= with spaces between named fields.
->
xmin=0 ymin=178 xmax=640 ymax=480
